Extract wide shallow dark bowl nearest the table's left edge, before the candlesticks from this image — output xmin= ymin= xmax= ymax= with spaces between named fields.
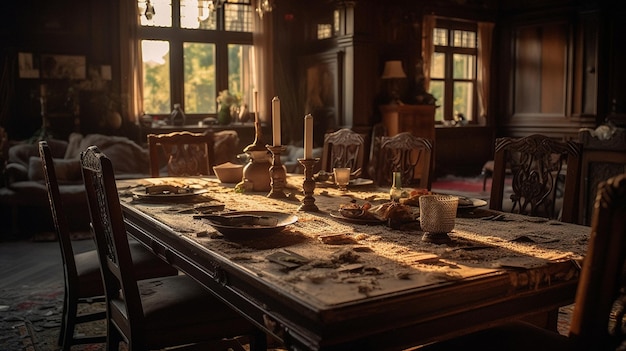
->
xmin=200 ymin=211 xmax=298 ymax=239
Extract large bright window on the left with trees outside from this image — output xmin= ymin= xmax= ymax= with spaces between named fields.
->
xmin=137 ymin=0 xmax=255 ymax=120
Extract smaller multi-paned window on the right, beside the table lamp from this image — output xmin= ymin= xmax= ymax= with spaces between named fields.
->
xmin=430 ymin=20 xmax=478 ymax=121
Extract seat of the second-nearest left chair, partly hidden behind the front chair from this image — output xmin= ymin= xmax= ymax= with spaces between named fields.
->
xmin=74 ymin=240 xmax=178 ymax=298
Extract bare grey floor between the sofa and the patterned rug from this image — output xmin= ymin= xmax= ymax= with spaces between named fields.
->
xmin=0 ymin=238 xmax=95 ymax=290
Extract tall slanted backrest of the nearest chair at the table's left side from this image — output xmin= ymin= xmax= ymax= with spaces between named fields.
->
xmin=80 ymin=146 xmax=144 ymax=340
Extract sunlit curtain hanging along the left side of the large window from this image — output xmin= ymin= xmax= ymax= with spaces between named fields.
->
xmin=120 ymin=0 xmax=144 ymax=123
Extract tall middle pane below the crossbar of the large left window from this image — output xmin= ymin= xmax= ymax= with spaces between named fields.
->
xmin=183 ymin=43 xmax=217 ymax=113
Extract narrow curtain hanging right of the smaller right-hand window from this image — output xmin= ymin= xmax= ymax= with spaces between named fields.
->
xmin=476 ymin=22 xmax=494 ymax=125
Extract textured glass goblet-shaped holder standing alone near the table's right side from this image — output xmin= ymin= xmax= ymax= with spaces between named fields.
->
xmin=419 ymin=195 xmax=459 ymax=243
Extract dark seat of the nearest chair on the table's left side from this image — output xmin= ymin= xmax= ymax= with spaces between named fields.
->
xmin=111 ymin=275 xmax=254 ymax=347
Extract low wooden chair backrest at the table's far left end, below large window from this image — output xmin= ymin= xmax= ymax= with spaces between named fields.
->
xmin=148 ymin=131 xmax=214 ymax=177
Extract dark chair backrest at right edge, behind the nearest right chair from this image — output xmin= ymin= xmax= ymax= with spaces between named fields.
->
xmin=578 ymin=126 xmax=626 ymax=225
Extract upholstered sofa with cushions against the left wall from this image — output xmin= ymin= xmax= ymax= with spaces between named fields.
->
xmin=0 ymin=133 xmax=149 ymax=236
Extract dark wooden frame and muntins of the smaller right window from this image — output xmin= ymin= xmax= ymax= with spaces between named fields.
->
xmin=430 ymin=18 xmax=479 ymax=124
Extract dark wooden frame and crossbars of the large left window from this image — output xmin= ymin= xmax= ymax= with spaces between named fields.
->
xmin=137 ymin=0 xmax=256 ymax=121
